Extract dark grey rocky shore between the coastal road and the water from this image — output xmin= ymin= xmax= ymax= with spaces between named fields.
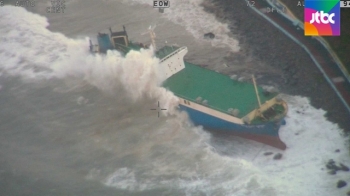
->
xmin=203 ymin=0 xmax=350 ymax=133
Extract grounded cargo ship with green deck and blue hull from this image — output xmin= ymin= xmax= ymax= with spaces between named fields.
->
xmin=90 ymin=27 xmax=288 ymax=150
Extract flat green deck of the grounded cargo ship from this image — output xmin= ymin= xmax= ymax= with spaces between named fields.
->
xmin=163 ymin=62 xmax=277 ymax=118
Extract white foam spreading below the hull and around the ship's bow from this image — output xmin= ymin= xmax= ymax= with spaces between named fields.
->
xmin=105 ymin=95 xmax=350 ymax=196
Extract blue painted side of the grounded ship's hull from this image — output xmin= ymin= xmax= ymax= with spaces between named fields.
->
xmin=179 ymin=105 xmax=286 ymax=150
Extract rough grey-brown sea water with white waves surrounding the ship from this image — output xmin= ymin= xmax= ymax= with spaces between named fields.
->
xmin=0 ymin=0 xmax=350 ymax=196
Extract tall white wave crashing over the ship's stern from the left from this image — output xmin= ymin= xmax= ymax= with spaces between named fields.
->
xmin=0 ymin=6 xmax=178 ymax=114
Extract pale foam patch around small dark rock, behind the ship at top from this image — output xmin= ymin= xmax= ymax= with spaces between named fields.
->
xmin=123 ymin=0 xmax=240 ymax=52
